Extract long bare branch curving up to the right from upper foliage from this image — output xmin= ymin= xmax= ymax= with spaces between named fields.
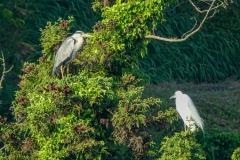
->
xmin=145 ymin=0 xmax=216 ymax=42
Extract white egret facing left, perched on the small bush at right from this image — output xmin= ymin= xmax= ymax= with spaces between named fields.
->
xmin=170 ymin=91 xmax=204 ymax=131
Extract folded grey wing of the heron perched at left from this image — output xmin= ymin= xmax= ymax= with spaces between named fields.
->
xmin=52 ymin=37 xmax=76 ymax=75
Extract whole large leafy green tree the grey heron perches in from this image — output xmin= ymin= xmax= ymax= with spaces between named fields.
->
xmin=2 ymin=1 xmax=174 ymax=159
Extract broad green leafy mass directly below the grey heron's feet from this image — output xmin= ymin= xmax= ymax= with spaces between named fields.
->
xmin=2 ymin=75 xmax=114 ymax=159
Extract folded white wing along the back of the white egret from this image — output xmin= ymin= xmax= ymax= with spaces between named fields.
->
xmin=186 ymin=95 xmax=204 ymax=131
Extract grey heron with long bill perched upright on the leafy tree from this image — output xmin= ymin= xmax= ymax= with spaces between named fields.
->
xmin=52 ymin=31 xmax=92 ymax=77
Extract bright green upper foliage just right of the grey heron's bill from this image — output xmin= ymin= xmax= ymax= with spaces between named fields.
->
xmin=79 ymin=0 xmax=175 ymax=75
